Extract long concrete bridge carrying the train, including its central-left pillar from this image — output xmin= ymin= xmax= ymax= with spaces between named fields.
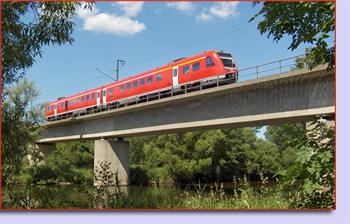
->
xmin=38 ymin=63 xmax=335 ymax=184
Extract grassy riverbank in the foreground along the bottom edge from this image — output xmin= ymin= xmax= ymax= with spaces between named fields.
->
xmin=2 ymin=179 xmax=293 ymax=209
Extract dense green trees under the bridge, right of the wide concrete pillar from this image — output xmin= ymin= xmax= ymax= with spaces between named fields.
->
xmin=130 ymin=128 xmax=281 ymax=183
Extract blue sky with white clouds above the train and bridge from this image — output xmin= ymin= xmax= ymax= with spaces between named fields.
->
xmin=27 ymin=1 xmax=334 ymax=137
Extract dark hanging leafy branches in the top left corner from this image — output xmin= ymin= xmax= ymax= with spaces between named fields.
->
xmin=1 ymin=1 xmax=94 ymax=90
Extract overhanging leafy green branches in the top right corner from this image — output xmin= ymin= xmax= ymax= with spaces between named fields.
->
xmin=250 ymin=1 xmax=335 ymax=69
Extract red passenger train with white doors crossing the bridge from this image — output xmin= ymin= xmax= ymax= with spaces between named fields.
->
xmin=45 ymin=51 xmax=238 ymax=121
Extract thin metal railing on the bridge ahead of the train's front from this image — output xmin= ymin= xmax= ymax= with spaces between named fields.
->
xmin=238 ymin=54 xmax=307 ymax=81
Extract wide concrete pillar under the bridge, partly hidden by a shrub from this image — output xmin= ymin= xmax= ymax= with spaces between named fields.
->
xmin=94 ymin=139 xmax=130 ymax=186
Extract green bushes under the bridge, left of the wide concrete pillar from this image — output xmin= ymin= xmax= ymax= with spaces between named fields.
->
xmin=13 ymin=141 xmax=93 ymax=185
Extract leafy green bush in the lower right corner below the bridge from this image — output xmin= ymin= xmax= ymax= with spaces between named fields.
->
xmin=279 ymin=121 xmax=335 ymax=209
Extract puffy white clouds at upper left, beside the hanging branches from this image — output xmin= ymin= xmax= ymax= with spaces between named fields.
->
xmin=77 ymin=2 xmax=146 ymax=36
